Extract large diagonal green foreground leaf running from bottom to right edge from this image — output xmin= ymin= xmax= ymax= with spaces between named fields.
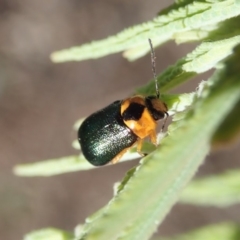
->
xmin=74 ymin=48 xmax=240 ymax=240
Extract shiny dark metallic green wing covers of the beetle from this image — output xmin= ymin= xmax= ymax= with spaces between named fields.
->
xmin=78 ymin=101 xmax=138 ymax=166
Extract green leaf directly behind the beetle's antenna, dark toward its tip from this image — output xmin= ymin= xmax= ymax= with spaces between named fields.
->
xmin=136 ymin=35 xmax=240 ymax=94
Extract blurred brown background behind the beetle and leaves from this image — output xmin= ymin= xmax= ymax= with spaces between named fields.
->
xmin=0 ymin=0 xmax=240 ymax=240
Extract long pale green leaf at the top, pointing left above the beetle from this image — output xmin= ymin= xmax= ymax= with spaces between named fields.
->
xmin=51 ymin=0 xmax=240 ymax=62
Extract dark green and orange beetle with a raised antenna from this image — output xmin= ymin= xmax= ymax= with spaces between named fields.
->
xmin=78 ymin=39 xmax=168 ymax=166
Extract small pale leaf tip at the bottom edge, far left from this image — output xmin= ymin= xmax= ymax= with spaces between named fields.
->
xmin=24 ymin=228 xmax=74 ymax=240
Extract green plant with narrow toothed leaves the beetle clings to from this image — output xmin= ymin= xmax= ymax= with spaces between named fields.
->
xmin=14 ymin=0 xmax=240 ymax=240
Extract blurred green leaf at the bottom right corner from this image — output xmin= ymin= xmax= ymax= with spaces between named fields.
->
xmin=152 ymin=222 xmax=240 ymax=240
